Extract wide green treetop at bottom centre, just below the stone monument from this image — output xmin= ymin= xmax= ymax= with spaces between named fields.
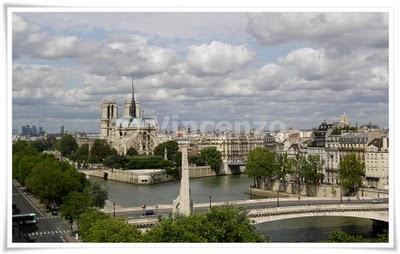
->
xmin=144 ymin=205 xmax=264 ymax=242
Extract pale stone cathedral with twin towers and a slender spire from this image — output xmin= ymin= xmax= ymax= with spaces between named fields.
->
xmin=100 ymin=79 xmax=158 ymax=154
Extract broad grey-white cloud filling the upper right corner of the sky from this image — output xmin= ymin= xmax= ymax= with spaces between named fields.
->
xmin=248 ymin=12 xmax=388 ymax=49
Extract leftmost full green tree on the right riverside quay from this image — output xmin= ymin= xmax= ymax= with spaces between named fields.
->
xmin=245 ymin=148 xmax=277 ymax=189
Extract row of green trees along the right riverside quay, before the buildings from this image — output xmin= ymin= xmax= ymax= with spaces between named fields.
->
xmin=245 ymin=148 xmax=365 ymax=196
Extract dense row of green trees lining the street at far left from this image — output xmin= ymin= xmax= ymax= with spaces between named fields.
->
xmin=13 ymin=141 xmax=107 ymax=223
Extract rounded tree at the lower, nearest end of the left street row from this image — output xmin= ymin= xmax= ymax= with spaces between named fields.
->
xmin=60 ymin=191 xmax=93 ymax=222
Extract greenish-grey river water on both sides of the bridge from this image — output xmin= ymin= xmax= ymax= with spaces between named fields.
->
xmin=89 ymin=175 xmax=388 ymax=242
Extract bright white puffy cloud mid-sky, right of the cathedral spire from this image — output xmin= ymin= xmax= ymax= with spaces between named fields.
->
xmin=187 ymin=41 xmax=254 ymax=76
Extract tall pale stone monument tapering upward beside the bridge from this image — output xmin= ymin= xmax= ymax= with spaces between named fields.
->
xmin=172 ymin=146 xmax=193 ymax=217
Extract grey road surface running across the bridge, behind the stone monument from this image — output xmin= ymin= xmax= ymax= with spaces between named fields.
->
xmin=111 ymin=198 xmax=388 ymax=219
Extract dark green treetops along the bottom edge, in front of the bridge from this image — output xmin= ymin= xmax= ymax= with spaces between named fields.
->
xmin=78 ymin=205 xmax=267 ymax=243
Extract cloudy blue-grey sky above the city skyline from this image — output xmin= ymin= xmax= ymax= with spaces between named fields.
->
xmin=12 ymin=12 xmax=389 ymax=132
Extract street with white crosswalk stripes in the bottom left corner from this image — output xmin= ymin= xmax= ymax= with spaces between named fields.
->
xmin=12 ymin=182 xmax=71 ymax=242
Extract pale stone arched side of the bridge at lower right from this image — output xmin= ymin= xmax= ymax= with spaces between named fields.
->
xmin=248 ymin=204 xmax=389 ymax=224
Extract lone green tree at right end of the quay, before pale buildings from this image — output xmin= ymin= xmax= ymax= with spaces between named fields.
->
xmin=339 ymin=153 xmax=365 ymax=194
